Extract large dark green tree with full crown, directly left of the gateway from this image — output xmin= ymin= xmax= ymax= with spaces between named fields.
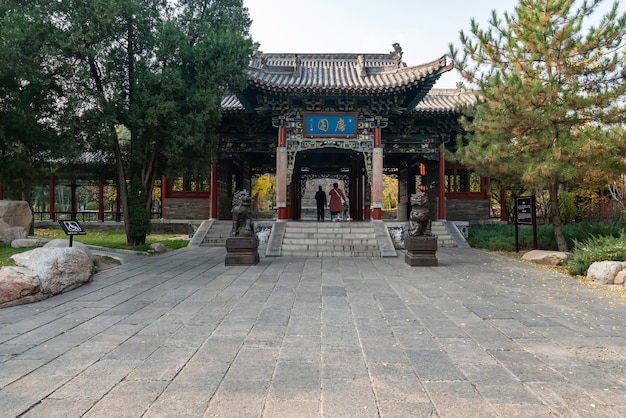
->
xmin=7 ymin=0 xmax=252 ymax=245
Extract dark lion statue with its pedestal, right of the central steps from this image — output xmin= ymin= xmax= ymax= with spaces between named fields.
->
xmin=404 ymin=192 xmax=439 ymax=267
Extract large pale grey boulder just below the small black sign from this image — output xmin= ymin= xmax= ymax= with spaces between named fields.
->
xmin=11 ymin=247 xmax=93 ymax=297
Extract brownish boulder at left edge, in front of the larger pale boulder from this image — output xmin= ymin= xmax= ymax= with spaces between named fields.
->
xmin=0 ymin=266 xmax=45 ymax=308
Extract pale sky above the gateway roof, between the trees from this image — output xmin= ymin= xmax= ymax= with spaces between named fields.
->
xmin=243 ymin=0 xmax=626 ymax=88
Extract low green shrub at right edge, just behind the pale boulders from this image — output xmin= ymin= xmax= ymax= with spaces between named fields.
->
xmin=566 ymin=230 xmax=626 ymax=275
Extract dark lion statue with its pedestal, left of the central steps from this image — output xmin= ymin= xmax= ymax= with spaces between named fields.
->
xmin=224 ymin=190 xmax=260 ymax=266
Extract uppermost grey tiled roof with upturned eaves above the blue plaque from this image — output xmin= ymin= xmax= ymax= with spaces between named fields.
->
xmin=248 ymin=44 xmax=452 ymax=93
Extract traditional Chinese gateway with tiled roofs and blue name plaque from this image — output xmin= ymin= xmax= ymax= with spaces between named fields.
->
xmin=173 ymin=44 xmax=489 ymax=221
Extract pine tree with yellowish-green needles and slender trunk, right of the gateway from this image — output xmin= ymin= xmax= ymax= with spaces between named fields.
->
xmin=450 ymin=0 xmax=626 ymax=251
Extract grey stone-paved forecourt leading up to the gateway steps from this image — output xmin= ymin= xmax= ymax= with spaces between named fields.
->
xmin=0 ymin=247 xmax=626 ymax=418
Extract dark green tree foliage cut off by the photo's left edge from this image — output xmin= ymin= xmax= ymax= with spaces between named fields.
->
xmin=0 ymin=0 xmax=71 ymax=199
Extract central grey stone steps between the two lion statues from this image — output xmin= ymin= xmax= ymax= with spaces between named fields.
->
xmin=281 ymin=221 xmax=381 ymax=257
